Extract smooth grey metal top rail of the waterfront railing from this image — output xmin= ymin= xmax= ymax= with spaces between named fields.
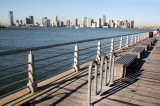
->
xmin=0 ymin=32 xmax=146 ymax=56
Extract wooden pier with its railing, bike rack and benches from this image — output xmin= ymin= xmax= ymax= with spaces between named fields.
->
xmin=0 ymin=31 xmax=160 ymax=106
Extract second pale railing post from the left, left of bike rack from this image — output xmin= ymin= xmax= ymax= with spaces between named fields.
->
xmin=73 ymin=44 xmax=79 ymax=72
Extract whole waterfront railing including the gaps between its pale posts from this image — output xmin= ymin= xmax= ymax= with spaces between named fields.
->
xmin=0 ymin=32 xmax=155 ymax=97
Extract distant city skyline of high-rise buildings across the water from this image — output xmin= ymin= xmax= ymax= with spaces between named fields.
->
xmin=6 ymin=11 xmax=134 ymax=28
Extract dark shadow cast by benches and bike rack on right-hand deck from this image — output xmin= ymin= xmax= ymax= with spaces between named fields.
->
xmin=93 ymin=41 xmax=157 ymax=106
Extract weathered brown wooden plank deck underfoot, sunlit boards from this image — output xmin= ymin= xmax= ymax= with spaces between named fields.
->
xmin=0 ymin=38 xmax=160 ymax=106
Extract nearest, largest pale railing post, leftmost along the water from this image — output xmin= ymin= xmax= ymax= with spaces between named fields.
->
xmin=27 ymin=51 xmax=37 ymax=93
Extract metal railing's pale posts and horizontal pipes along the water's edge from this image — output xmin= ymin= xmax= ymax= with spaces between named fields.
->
xmin=0 ymin=30 xmax=154 ymax=97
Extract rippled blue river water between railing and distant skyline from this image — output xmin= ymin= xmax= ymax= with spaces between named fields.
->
xmin=0 ymin=28 xmax=153 ymax=95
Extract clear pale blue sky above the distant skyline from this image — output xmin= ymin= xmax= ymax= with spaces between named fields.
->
xmin=0 ymin=0 xmax=160 ymax=26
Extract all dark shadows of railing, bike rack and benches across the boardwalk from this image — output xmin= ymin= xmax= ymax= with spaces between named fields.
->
xmin=20 ymin=40 xmax=157 ymax=106
